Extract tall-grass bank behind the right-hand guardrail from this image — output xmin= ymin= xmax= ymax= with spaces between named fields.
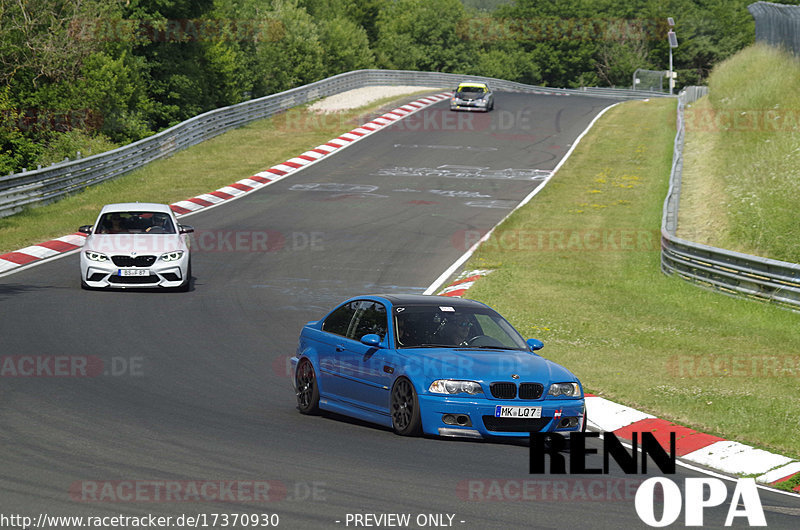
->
xmin=678 ymin=45 xmax=800 ymax=263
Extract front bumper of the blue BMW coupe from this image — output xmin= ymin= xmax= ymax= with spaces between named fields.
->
xmin=419 ymin=394 xmax=585 ymax=438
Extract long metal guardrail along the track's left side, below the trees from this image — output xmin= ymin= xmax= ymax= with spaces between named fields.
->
xmin=0 ymin=70 xmax=663 ymax=217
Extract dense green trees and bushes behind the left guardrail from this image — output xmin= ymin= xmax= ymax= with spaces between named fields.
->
xmin=0 ymin=0 xmax=753 ymax=174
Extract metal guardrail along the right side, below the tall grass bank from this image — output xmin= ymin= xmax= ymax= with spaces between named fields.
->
xmin=661 ymin=87 xmax=800 ymax=311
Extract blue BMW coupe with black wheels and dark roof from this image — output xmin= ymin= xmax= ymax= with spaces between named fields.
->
xmin=292 ymin=295 xmax=586 ymax=438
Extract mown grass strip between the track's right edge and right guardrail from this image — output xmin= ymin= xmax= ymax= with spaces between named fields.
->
xmin=467 ymin=99 xmax=800 ymax=458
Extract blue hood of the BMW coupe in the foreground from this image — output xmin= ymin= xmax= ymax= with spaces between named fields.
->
xmin=397 ymin=348 xmax=578 ymax=385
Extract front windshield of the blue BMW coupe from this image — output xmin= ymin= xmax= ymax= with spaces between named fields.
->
xmin=392 ymin=305 xmax=528 ymax=350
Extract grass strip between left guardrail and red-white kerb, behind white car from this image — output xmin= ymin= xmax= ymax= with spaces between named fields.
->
xmin=0 ymin=91 xmax=438 ymax=254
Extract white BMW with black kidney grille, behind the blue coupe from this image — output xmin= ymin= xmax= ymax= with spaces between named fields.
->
xmin=78 ymin=202 xmax=194 ymax=291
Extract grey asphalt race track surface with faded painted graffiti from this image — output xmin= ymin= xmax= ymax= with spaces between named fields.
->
xmin=0 ymin=94 xmax=800 ymax=529
